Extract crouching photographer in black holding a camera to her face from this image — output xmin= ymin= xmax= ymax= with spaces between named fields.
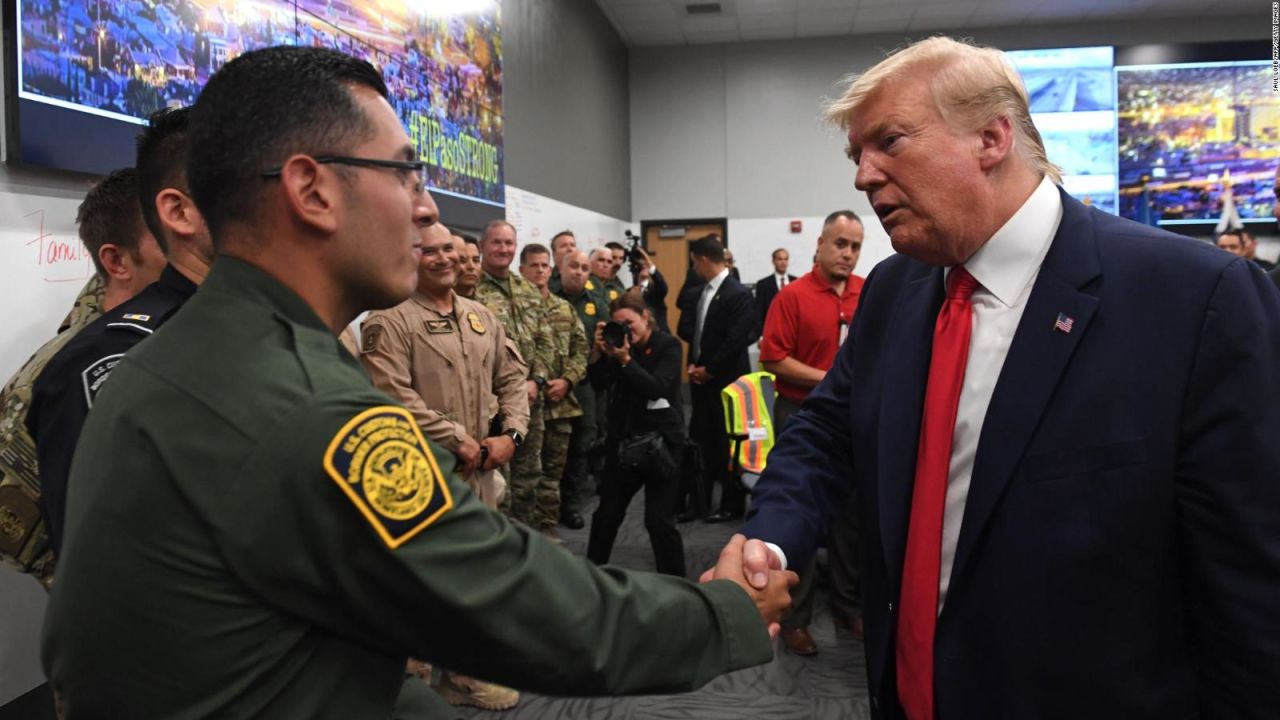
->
xmin=586 ymin=288 xmax=685 ymax=577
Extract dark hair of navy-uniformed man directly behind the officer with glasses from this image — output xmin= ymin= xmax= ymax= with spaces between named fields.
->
xmin=134 ymin=108 xmax=191 ymax=252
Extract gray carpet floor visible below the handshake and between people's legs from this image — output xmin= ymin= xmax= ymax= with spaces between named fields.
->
xmin=445 ymin=493 xmax=870 ymax=720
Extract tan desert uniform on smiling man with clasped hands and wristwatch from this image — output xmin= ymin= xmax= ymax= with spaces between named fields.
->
xmin=360 ymin=293 xmax=529 ymax=507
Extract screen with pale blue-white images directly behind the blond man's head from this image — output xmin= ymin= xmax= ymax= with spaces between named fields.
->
xmin=1005 ymin=47 xmax=1116 ymax=213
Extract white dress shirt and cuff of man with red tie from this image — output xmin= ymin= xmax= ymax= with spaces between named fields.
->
xmin=767 ymin=178 xmax=1062 ymax=604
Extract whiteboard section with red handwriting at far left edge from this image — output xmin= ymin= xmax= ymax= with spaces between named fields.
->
xmin=0 ymin=168 xmax=95 ymax=382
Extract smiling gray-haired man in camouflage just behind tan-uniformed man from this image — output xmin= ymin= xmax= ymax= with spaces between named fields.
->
xmin=476 ymin=215 xmax=554 ymax=530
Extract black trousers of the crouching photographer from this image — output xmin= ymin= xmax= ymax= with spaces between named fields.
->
xmin=586 ymin=437 xmax=685 ymax=578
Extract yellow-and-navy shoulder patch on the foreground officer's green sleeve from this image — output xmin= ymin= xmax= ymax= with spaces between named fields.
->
xmin=324 ymin=405 xmax=453 ymax=550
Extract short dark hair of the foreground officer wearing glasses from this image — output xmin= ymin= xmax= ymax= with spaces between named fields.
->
xmin=187 ymin=46 xmax=387 ymax=245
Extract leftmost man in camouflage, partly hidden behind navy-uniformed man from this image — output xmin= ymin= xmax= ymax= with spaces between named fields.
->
xmin=0 ymin=168 xmax=164 ymax=587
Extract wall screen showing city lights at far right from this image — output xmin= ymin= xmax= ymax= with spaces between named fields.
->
xmin=1116 ymin=60 xmax=1280 ymax=225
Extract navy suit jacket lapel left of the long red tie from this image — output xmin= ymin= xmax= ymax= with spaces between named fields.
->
xmin=876 ymin=266 xmax=943 ymax=594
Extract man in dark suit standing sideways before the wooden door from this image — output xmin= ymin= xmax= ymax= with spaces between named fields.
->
xmin=677 ymin=234 xmax=755 ymax=523
